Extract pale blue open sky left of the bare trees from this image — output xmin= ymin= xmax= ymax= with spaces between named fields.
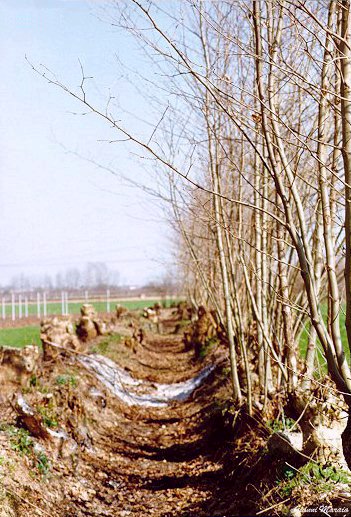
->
xmin=0 ymin=0 xmax=168 ymax=284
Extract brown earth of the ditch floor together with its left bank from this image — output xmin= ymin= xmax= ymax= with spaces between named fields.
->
xmin=0 ymin=310 xmax=263 ymax=517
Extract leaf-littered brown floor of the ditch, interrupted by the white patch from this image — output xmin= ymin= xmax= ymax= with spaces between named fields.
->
xmin=72 ymin=336 xmax=234 ymax=517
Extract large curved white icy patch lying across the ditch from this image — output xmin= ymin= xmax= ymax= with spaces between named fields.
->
xmin=79 ymin=354 xmax=215 ymax=407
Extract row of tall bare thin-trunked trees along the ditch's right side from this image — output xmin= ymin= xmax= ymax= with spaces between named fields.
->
xmin=36 ymin=0 xmax=351 ymax=461
